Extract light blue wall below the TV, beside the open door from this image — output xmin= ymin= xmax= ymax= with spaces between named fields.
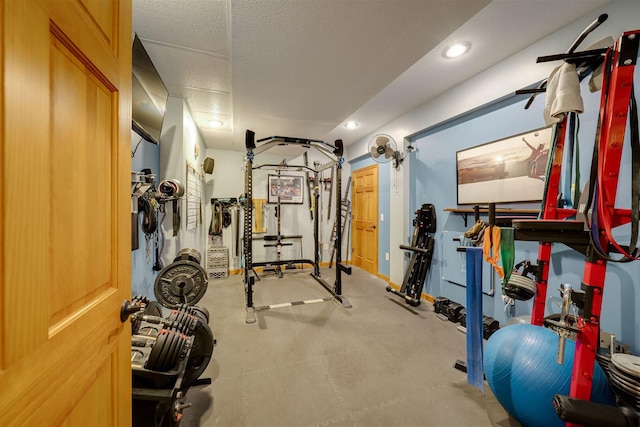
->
xmin=131 ymin=132 xmax=160 ymax=300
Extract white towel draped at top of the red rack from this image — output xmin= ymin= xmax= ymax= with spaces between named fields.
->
xmin=543 ymin=62 xmax=584 ymax=126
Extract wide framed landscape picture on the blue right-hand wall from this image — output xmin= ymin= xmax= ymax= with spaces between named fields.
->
xmin=456 ymin=127 xmax=552 ymax=205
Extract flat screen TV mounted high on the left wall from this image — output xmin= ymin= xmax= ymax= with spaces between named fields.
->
xmin=131 ymin=35 xmax=169 ymax=144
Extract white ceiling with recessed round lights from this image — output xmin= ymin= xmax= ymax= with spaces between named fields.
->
xmin=133 ymin=0 xmax=609 ymax=151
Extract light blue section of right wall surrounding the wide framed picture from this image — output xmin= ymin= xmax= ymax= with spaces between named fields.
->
xmin=410 ymin=58 xmax=640 ymax=351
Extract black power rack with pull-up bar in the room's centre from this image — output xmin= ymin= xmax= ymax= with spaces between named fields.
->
xmin=244 ymin=130 xmax=351 ymax=323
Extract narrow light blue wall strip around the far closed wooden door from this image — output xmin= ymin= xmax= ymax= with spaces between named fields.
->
xmin=349 ymin=155 xmax=392 ymax=277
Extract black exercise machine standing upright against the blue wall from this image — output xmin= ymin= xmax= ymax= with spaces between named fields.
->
xmin=386 ymin=203 xmax=436 ymax=307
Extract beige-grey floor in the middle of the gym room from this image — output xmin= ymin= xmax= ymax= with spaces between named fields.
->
xmin=181 ymin=268 xmax=518 ymax=427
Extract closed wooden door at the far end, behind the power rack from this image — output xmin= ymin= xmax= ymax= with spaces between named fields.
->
xmin=352 ymin=164 xmax=378 ymax=274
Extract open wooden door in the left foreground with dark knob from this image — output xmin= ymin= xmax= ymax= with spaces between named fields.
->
xmin=0 ymin=0 xmax=131 ymax=427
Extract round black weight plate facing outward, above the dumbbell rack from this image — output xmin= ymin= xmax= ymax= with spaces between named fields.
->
xmin=154 ymin=261 xmax=208 ymax=308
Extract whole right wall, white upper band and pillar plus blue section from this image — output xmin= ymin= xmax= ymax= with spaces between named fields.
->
xmin=347 ymin=0 xmax=640 ymax=352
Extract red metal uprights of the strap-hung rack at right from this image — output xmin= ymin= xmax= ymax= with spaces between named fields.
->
xmin=531 ymin=30 xmax=640 ymax=426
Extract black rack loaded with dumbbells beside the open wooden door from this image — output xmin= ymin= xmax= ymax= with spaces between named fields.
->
xmin=126 ymin=296 xmax=216 ymax=427
